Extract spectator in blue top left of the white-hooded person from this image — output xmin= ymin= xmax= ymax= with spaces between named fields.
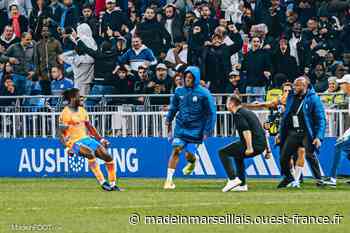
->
xmin=51 ymin=65 xmax=74 ymax=96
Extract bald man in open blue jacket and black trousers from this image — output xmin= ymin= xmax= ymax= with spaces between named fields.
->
xmin=278 ymin=76 xmax=326 ymax=188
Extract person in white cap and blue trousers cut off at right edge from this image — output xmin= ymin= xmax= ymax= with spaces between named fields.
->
xmin=324 ymin=74 xmax=350 ymax=187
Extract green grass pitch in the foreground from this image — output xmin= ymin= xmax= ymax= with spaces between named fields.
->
xmin=0 ymin=178 xmax=350 ymax=233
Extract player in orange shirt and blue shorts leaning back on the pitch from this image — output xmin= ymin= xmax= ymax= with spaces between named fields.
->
xmin=59 ymin=88 xmax=121 ymax=191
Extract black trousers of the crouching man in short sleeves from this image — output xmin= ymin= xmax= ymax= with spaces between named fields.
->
xmin=219 ymin=141 xmax=265 ymax=185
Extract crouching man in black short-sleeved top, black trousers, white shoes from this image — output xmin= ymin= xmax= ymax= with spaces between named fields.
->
xmin=219 ymin=95 xmax=267 ymax=192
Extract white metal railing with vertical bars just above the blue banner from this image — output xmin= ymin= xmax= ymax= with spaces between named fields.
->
xmin=0 ymin=109 xmax=350 ymax=138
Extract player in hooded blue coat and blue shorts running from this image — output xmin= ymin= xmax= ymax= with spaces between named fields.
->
xmin=164 ymin=66 xmax=216 ymax=189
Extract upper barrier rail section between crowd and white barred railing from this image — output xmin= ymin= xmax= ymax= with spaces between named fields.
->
xmin=0 ymin=93 xmax=347 ymax=113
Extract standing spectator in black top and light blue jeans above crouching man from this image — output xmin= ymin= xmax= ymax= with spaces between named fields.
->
xmin=241 ymin=37 xmax=271 ymax=103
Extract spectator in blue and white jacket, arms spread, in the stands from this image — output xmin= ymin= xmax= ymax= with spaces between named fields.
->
xmin=119 ymin=35 xmax=157 ymax=71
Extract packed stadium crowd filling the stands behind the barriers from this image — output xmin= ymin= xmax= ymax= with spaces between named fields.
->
xmin=0 ymin=0 xmax=350 ymax=105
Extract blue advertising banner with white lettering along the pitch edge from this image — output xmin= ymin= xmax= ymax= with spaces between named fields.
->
xmin=0 ymin=137 xmax=344 ymax=178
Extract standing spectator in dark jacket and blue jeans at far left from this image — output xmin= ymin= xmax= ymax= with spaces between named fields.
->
xmin=0 ymin=32 xmax=34 ymax=95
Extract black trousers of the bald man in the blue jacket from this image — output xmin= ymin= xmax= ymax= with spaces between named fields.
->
xmin=280 ymin=130 xmax=321 ymax=179
